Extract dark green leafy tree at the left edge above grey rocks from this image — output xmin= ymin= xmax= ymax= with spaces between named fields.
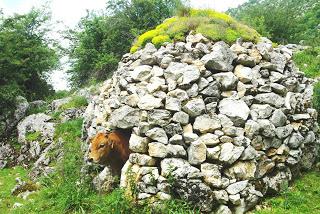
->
xmin=0 ymin=9 xmax=59 ymax=115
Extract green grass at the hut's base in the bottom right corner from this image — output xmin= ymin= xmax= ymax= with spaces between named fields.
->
xmin=255 ymin=172 xmax=320 ymax=214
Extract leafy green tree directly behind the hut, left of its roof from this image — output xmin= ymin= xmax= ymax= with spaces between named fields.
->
xmin=69 ymin=0 xmax=186 ymax=86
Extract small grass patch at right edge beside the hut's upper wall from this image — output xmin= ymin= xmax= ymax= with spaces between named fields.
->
xmin=293 ymin=47 xmax=320 ymax=78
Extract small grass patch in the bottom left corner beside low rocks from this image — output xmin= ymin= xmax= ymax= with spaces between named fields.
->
xmin=0 ymin=166 xmax=27 ymax=213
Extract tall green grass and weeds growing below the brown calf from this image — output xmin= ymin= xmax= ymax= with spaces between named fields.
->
xmin=10 ymin=119 xmax=199 ymax=214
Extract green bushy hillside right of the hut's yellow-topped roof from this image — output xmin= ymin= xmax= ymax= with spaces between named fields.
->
xmin=228 ymin=0 xmax=320 ymax=45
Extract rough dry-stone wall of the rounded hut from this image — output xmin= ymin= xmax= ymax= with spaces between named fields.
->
xmin=84 ymin=34 xmax=319 ymax=213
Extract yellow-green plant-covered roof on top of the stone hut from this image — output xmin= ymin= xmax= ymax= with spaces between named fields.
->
xmin=131 ymin=9 xmax=260 ymax=53
